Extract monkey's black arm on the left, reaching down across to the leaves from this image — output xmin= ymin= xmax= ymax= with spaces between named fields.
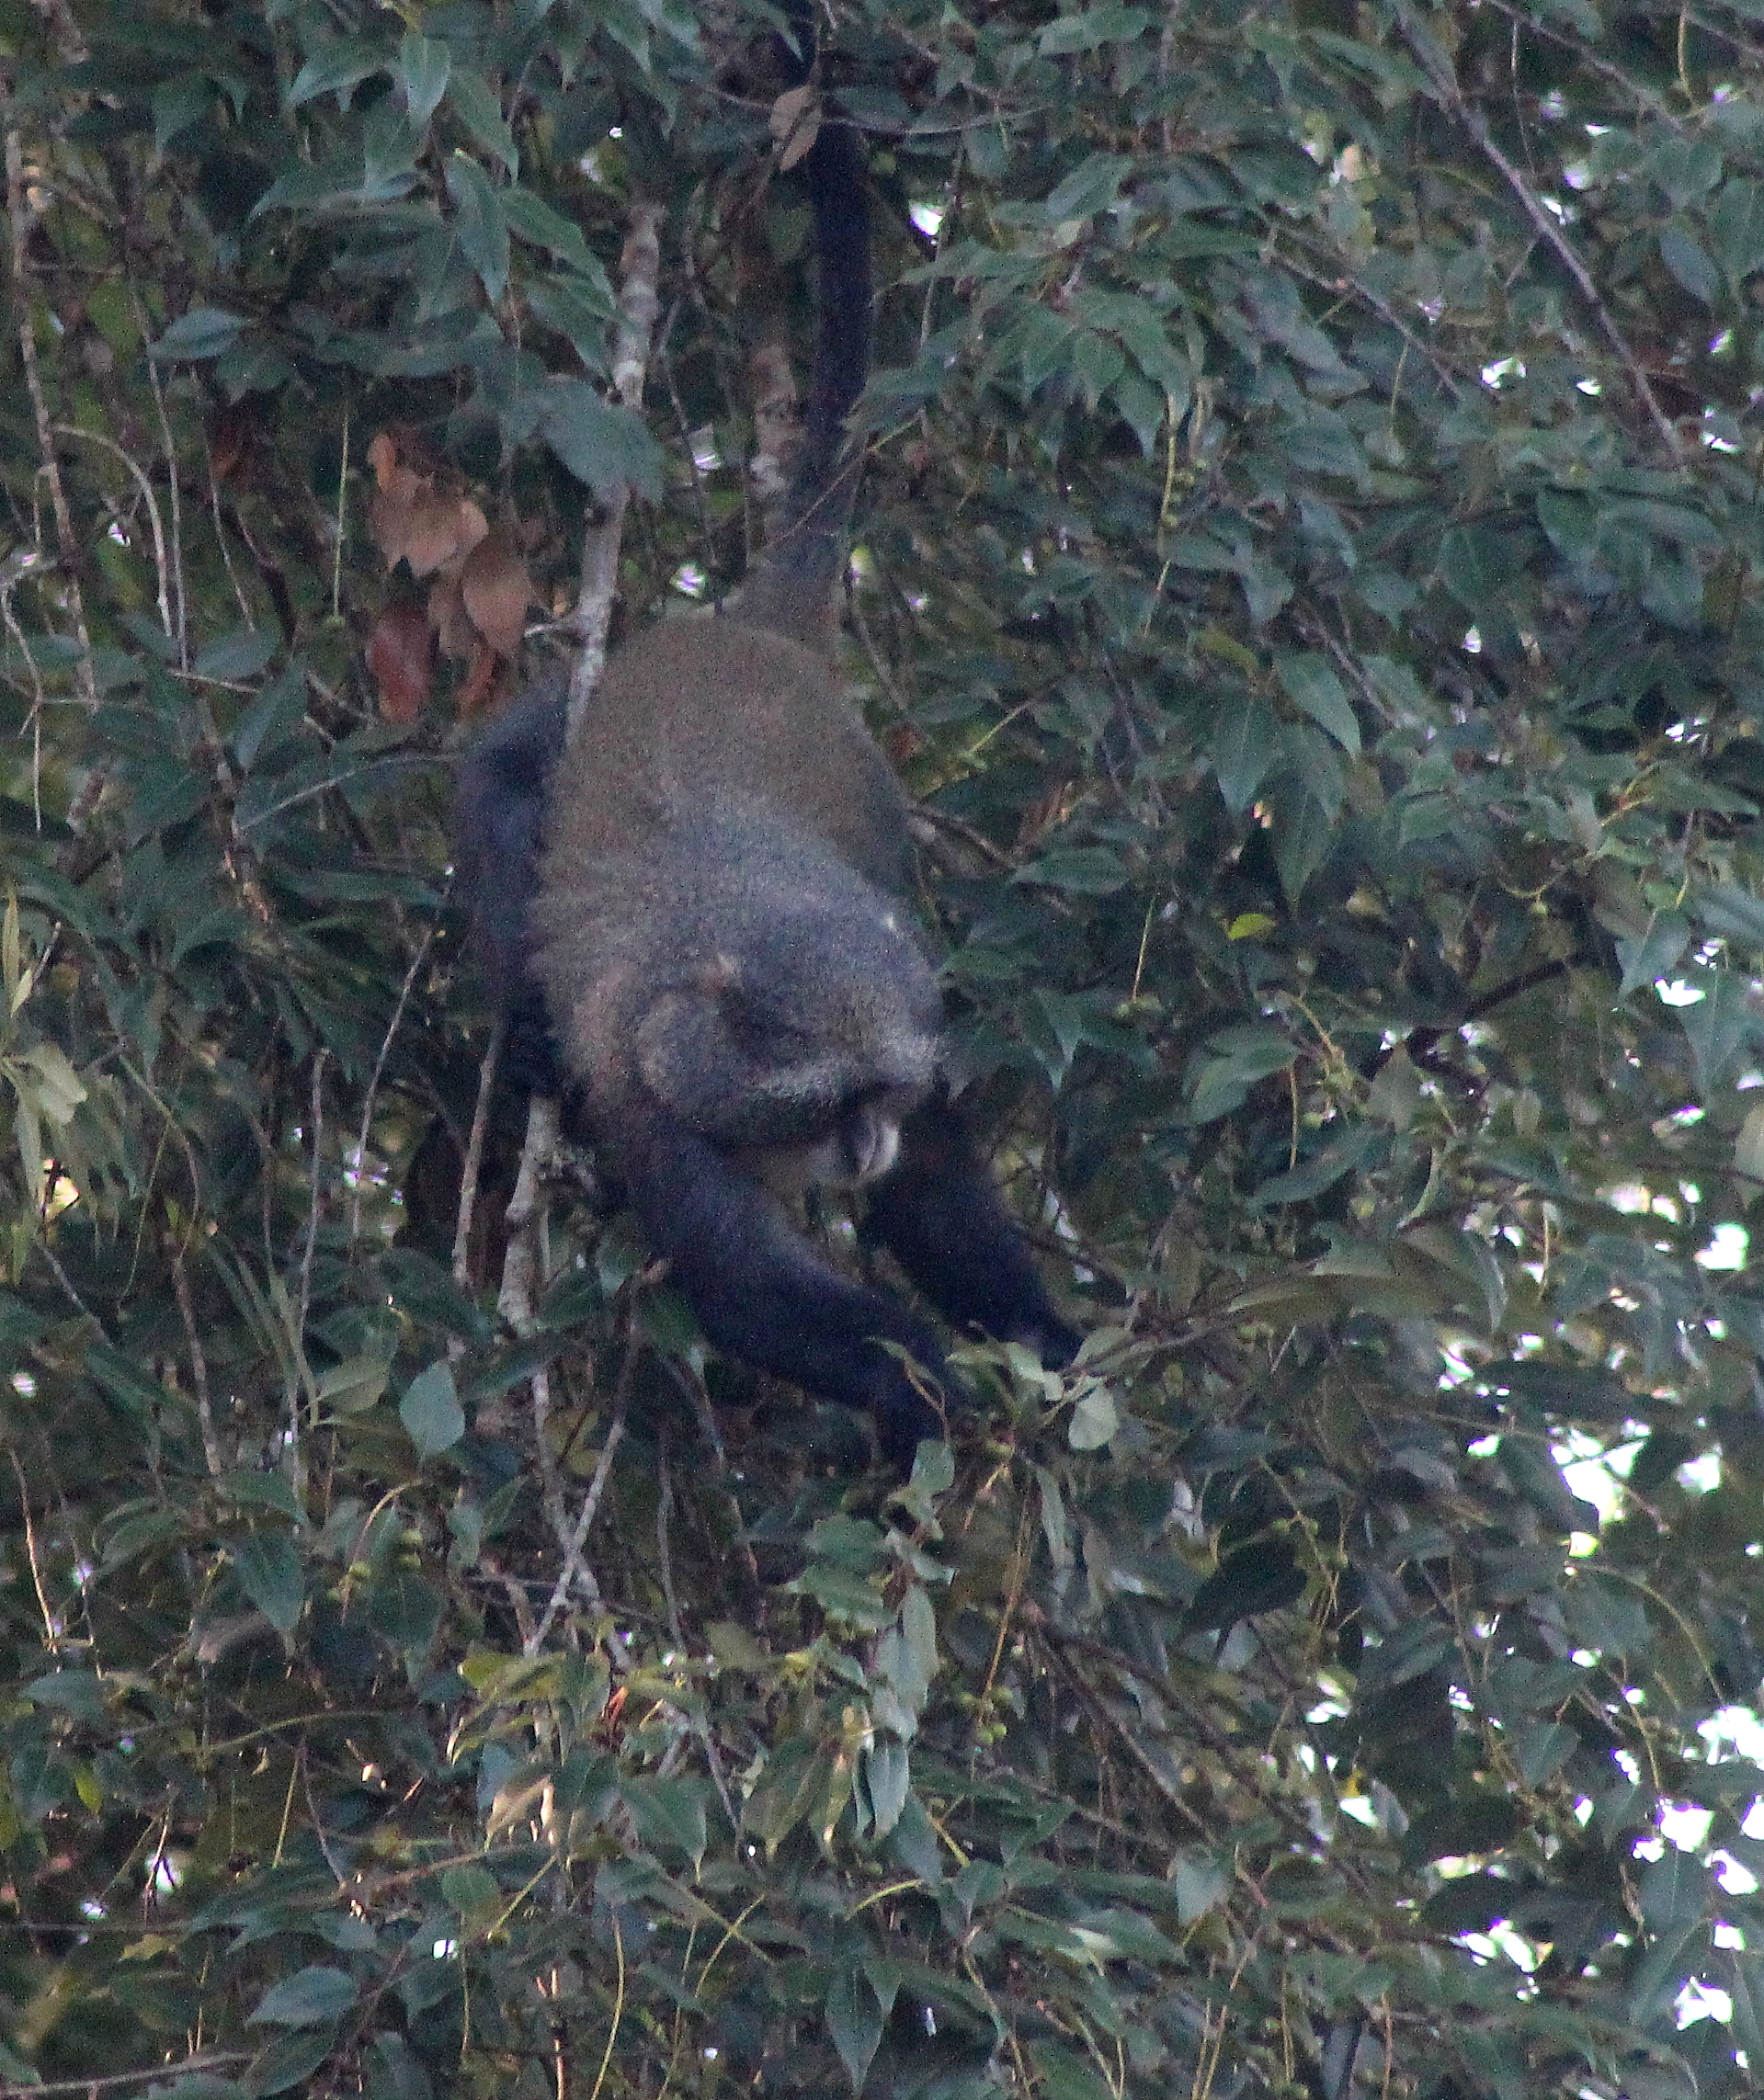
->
xmin=613 ymin=1111 xmax=947 ymax=1470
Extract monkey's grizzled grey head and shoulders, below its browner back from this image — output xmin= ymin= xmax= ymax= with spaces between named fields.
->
xmin=533 ymin=789 xmax=939 ymax=1193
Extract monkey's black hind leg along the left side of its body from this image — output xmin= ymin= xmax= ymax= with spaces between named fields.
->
xmin=453 ymin=674 xmax=567 ymax=1094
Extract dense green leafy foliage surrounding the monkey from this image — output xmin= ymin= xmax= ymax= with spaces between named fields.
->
xmin=0 ymin=0 xmax=1764 ymax=2100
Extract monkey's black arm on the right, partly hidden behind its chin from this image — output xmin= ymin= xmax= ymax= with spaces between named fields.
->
xmin=868 ymin=1094 xmax=1079 ymax=1369
